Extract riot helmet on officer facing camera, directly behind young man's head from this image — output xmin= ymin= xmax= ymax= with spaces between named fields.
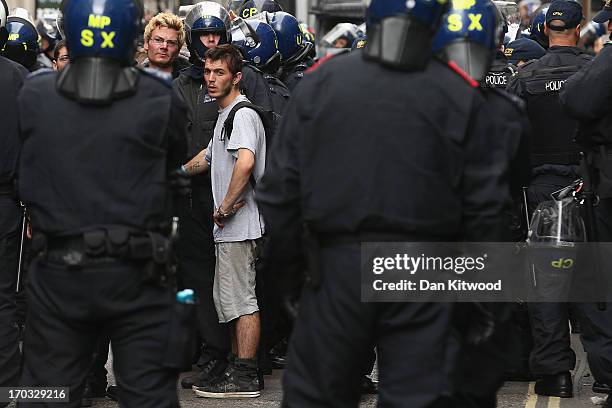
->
xmin=185 ymin=1 xmax=232 ymax=61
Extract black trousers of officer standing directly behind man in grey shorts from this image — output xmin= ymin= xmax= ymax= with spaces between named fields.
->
xmin=178 ymin=184 xmax=230 ymax=367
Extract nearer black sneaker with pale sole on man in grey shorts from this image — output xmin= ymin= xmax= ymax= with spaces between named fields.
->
xmin=193 ymin=358 xmax=262 ymax=398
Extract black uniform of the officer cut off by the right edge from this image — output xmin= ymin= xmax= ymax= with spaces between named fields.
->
xmin=560 ymin=45 xmax=612 ymax=384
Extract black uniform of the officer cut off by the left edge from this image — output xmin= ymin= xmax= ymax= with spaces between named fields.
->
xmin=0 ymin=52 xmax=28 ymax=405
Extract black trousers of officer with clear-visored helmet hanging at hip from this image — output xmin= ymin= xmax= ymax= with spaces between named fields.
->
xmin=527 ymin=170 xmax=578 ymax=377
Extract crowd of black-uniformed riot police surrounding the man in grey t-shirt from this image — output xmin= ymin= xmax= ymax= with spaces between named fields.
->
xmin=0 ymin=0 xmax=612 ymax=407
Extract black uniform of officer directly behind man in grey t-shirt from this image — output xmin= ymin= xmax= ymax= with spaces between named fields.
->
xmin=173 ymin=62 xmax=273 ymax=374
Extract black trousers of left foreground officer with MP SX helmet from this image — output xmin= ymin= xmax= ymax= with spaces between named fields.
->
xmin=20 ymin=259 xmax=188 ymax=408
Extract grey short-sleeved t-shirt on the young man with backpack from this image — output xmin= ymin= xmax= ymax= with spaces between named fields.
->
xmin=206 ymin=95 xmax=266 ymax=242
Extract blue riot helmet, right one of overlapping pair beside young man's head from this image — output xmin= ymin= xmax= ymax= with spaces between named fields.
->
xmin=262 ymin=11 xmax=314 ymax=66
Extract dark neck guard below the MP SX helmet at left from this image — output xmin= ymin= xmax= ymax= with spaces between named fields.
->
xmin=57 ymin=57 xmax=138 ymax=105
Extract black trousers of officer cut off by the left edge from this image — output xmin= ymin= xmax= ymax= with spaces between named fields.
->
xmin=0 ymin=193 xmax=21 ymax=400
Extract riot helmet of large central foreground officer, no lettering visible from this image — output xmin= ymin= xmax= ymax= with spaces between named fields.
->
xmin=363 ymin=0 xmax=448 ymax=71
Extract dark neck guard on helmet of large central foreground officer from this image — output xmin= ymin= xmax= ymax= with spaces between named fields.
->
xmin=363 ymin=16 xmax=432 ymax=71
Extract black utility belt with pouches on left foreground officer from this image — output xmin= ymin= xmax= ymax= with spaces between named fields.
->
xmin=32 ymin=227 xmax=172 ymax=268
